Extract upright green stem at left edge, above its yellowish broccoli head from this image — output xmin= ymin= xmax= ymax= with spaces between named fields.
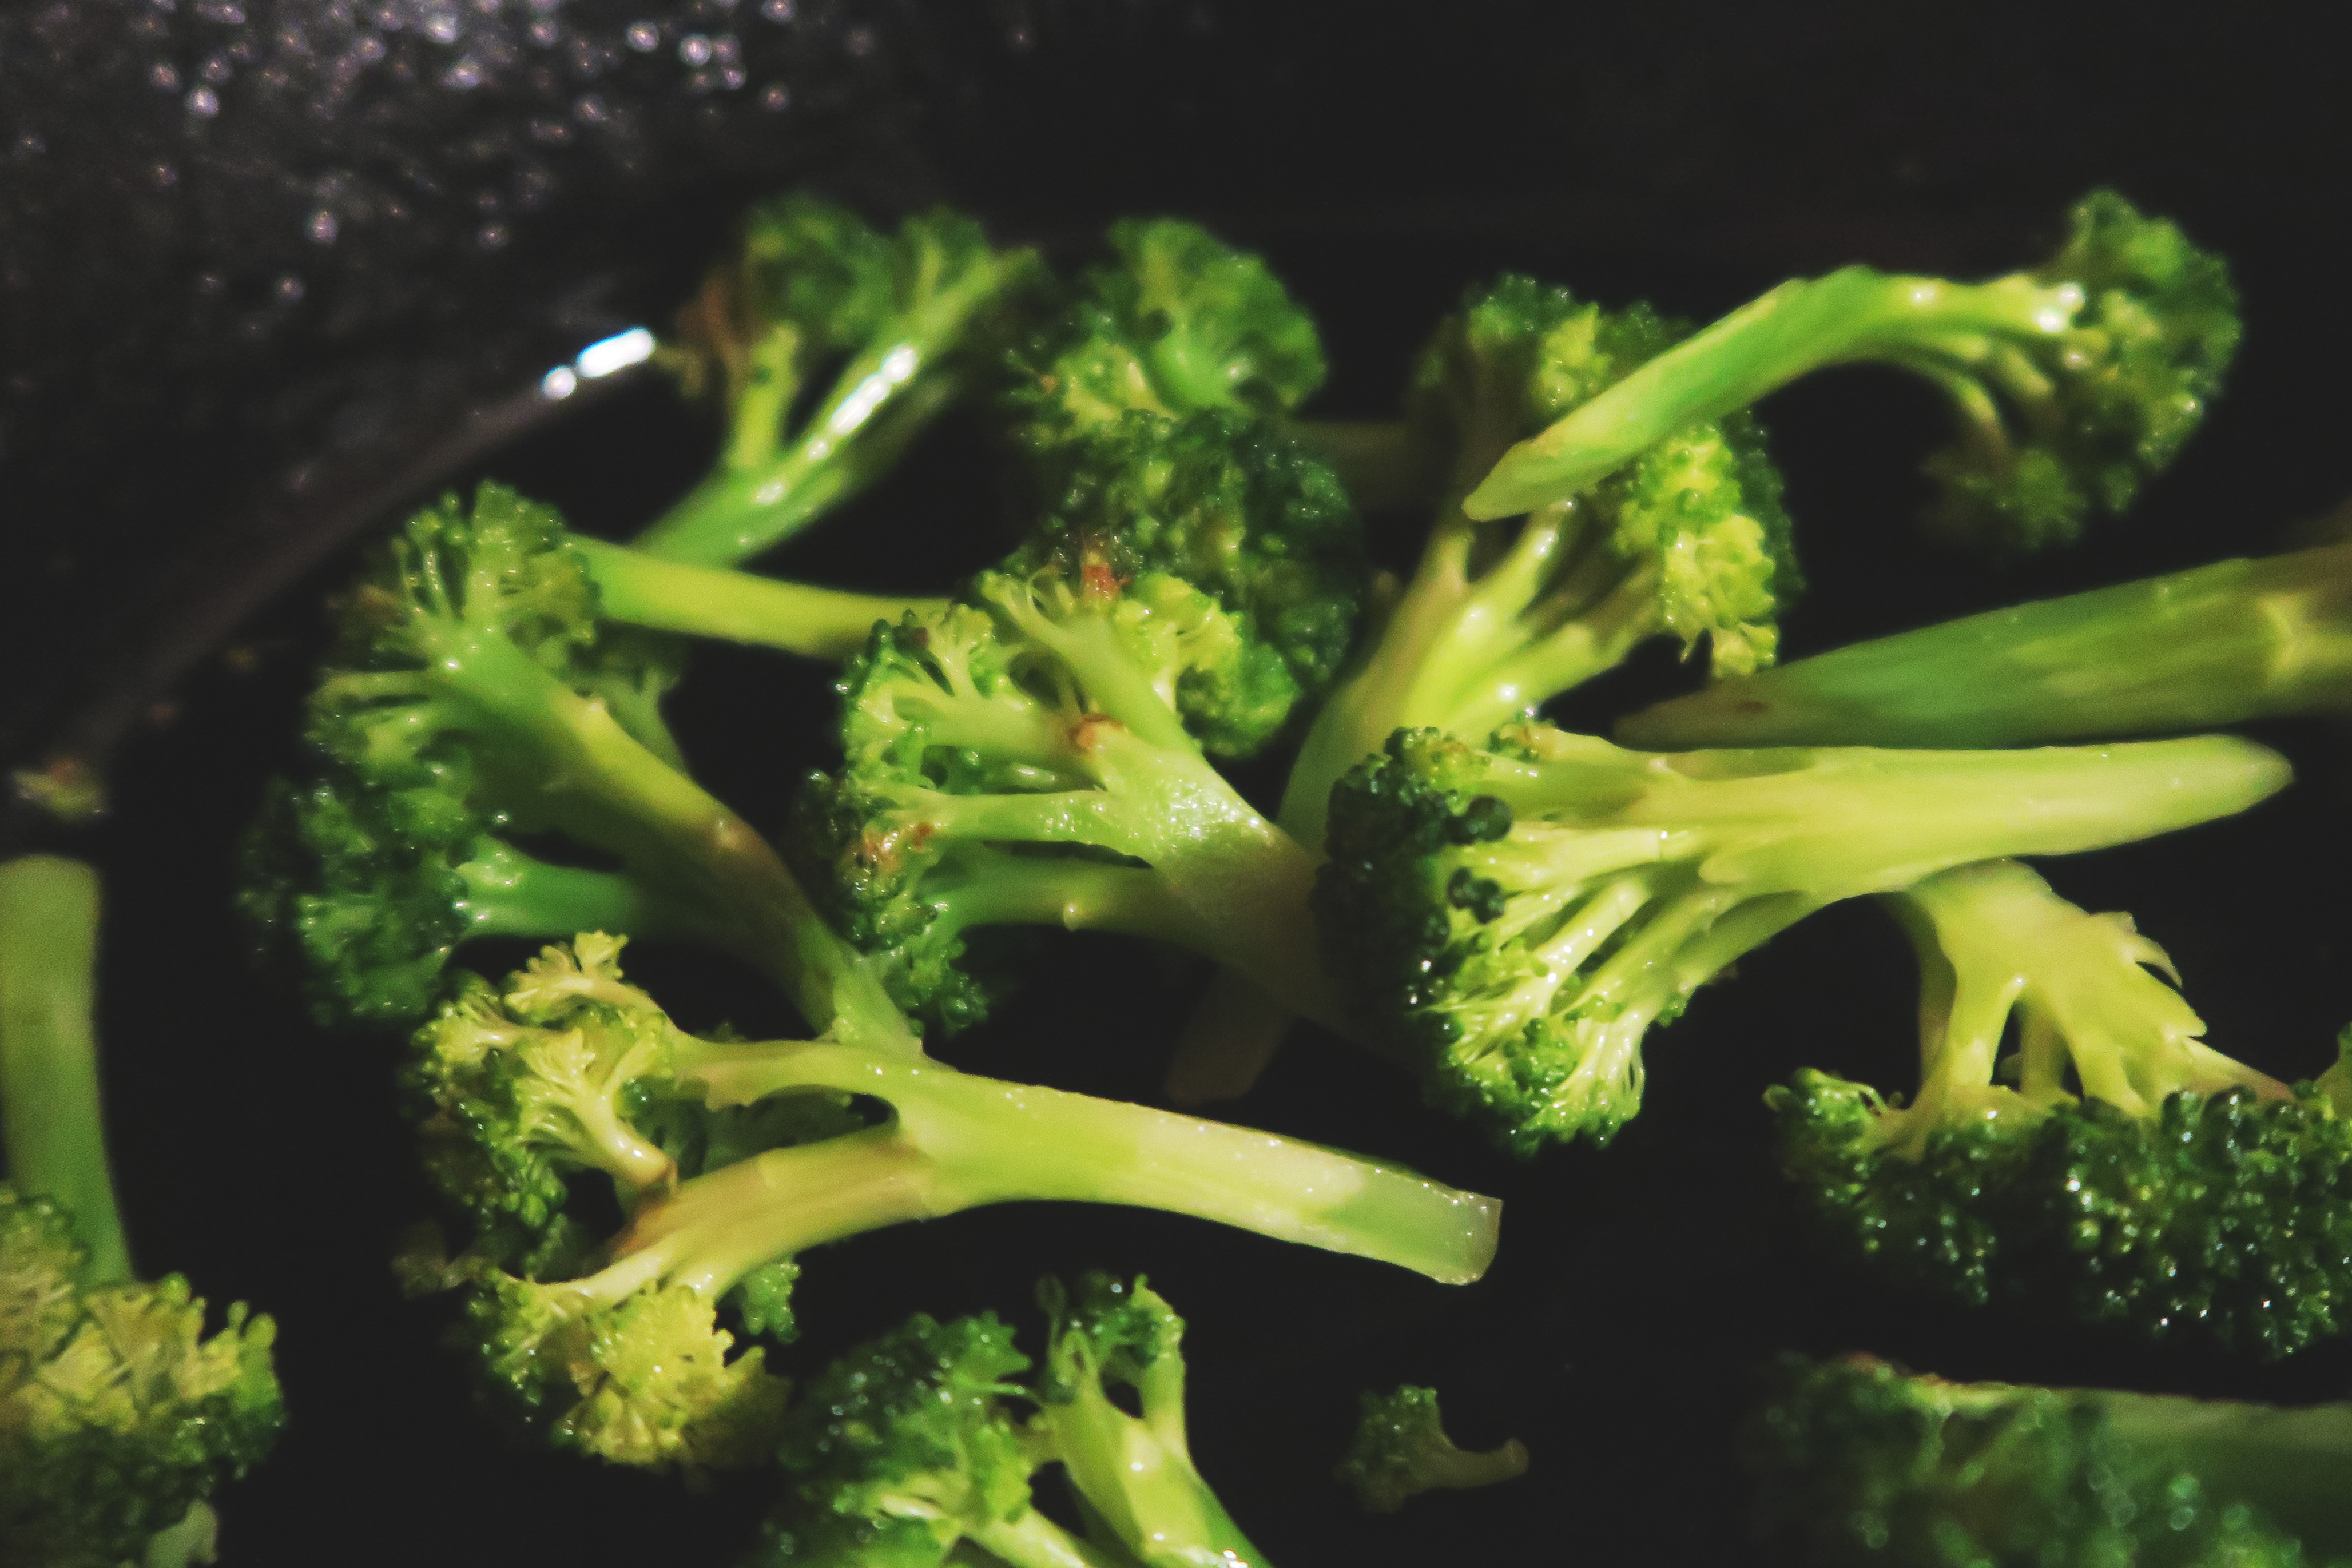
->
xmin=0 ymin=855 xmax=132 ymax=1286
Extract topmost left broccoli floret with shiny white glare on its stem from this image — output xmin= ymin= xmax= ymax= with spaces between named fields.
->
xmin=635 ymin=195 xmax=1037 ymax=567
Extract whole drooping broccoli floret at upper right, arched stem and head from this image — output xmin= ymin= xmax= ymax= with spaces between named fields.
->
xmin=1463 ymin=190 xmax=2239 ymax=550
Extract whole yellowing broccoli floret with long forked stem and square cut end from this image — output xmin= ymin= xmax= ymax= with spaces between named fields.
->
xmin=409 ymin=933 xmax=1496 ymax=1467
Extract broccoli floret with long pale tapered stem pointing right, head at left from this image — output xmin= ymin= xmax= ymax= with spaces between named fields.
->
xmin=1315 ymin=724 xmax=2289 ymax=1152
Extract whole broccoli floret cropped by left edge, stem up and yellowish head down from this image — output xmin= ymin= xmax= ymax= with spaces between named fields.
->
xmin=0 ymin=855 xmax=285 ymax=1568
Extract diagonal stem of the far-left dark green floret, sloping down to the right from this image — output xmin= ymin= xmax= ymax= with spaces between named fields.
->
xmin=395 ymin=618 xmax=915 ymax=1048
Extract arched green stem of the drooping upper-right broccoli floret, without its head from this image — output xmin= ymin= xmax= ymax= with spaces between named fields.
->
xmin=1463 ymin=266 xmax=2081 ymax=520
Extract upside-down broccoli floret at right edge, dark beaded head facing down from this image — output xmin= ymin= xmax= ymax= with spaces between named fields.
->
xmin=1771 ymin=851 xmax=2352 ymax=1356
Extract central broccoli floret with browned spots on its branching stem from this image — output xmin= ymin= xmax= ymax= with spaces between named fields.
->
xmin=790 ymin=527 xmax=1341 ymax=1044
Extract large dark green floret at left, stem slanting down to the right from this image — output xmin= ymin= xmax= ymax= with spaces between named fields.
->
xmin=243 ymin=484 xmax=899 ymax=1034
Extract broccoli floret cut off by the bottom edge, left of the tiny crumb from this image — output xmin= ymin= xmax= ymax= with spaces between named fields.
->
xmin=753 ymin=1274 xmax=1268 ymax=1568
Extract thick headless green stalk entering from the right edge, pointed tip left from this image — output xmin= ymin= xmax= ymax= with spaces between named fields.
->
xmin=1618 ymin=546 xmax=2352 ymax=747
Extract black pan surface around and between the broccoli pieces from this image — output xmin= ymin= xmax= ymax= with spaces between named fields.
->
xmin=0 ymin=0 xmax=2352 ymax=1566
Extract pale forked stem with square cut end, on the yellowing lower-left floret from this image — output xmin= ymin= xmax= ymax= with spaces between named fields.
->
xmin=616 ymin=1041 xmax=1500 ymax=1300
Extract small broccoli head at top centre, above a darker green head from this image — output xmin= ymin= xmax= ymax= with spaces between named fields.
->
xmin=1011 ymin=218 xmax=1324 ymax=456
